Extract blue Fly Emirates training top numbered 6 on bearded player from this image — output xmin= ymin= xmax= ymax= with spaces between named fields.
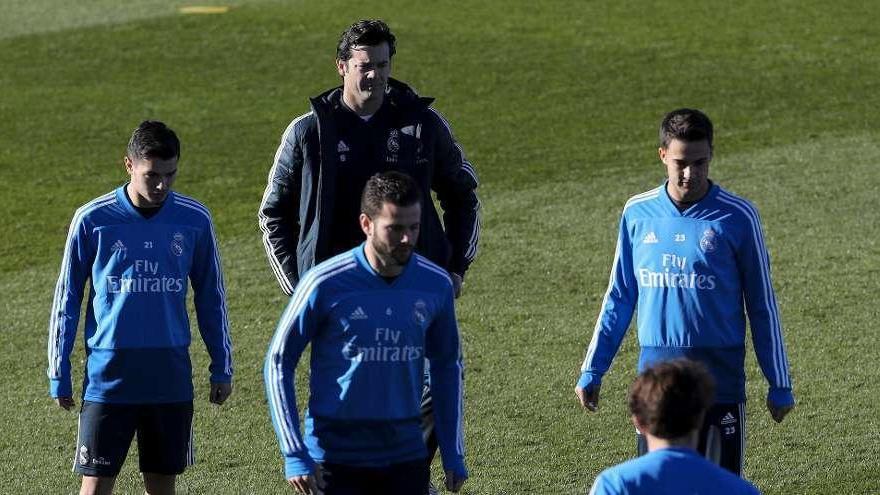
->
xmin=264 ymin=244 xmax=467 ymax=478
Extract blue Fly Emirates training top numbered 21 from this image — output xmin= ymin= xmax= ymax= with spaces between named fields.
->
xmin=48 ymin=186 xmax=232 ymax=403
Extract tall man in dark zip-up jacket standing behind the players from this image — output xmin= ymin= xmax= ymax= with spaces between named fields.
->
xmin=259 ymin=20 xmax=480 ymax=492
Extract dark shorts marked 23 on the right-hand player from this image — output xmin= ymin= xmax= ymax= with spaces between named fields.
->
xmin=637 ymin=403 xmax=746 ymax=476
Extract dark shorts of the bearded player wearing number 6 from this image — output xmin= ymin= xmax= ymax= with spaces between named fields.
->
xmin=313 ymin=459 xmax=431 ymax=495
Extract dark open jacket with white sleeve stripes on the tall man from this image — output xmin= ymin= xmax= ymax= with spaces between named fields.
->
xmin=258 ymin=79 xmax=480 ymax=295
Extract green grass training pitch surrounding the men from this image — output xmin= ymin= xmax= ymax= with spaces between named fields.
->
xmin=0 ymin=0 xmax=880 ymax=494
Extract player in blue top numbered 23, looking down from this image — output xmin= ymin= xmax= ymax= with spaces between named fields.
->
xmin=575 ymin=109 xmax=794 ymax=474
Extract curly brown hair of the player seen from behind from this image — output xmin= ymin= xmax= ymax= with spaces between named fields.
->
xmin=629 ymin=359 xmax=715 ymax=439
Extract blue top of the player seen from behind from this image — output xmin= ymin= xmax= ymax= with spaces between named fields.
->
xmin=590 ymin=447 xmax=760 ymax=495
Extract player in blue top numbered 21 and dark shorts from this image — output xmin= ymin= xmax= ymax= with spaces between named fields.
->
xmin=48 ymin=121 xmax=232 ymax=494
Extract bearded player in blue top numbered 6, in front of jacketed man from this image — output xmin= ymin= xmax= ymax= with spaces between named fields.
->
xmin=264 ymin=172 xmax=467 ymax=495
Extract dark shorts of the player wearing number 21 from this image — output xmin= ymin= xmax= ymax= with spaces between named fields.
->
xmin=73 ymin=401 xmax=195 ymax=477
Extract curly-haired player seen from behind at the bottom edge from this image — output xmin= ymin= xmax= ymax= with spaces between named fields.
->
xmin=590 ymin=359 xmax=760 ymax=495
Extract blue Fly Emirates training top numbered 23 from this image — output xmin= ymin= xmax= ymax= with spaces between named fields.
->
xmin=578 ymin=184 xmax=794 ymax=406
